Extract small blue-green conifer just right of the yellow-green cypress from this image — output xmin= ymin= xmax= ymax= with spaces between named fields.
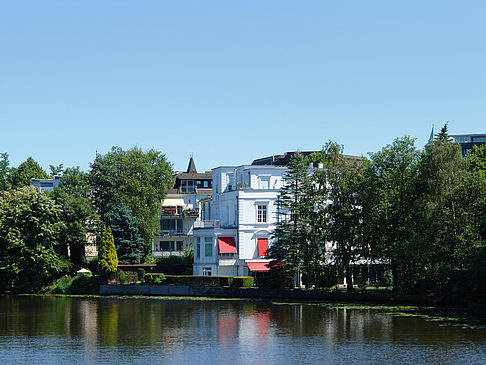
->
xmin=105 ymin=203 xmax=144 ymax=264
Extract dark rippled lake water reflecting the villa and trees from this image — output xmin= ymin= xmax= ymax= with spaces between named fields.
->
xmin=0 ymin=296 xmax=486 ymax=365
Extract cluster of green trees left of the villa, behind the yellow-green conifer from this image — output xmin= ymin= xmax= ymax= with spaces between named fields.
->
xmin=0 ymin=147 xmax=172 ymax=292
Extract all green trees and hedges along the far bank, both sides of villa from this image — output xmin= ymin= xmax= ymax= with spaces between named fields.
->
xmin=0 ymin=126 xmax=486 ymax=307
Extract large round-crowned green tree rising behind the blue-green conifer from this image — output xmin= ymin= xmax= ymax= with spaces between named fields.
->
xmin=89 ymin=147 xmax=173 ymax=256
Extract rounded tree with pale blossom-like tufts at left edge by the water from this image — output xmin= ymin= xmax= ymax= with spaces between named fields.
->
xmin=0 ymin=187 xmax=70 ymax=293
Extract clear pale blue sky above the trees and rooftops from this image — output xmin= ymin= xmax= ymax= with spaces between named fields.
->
xmin=0 ymin=0 xmax=486 ymax=171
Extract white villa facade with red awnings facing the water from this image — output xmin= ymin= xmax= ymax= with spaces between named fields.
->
xmin=194 ymin=165 xmax=287 ymax=276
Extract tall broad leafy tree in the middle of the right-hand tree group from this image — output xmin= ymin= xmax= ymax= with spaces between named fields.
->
xmin=362 ymin=137 xmax=423 ymax=291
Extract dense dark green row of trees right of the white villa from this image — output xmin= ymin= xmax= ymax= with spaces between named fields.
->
xmin=269 ymin=126 xmax=486 ymax=299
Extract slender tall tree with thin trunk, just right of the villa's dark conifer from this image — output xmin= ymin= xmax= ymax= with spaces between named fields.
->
xmin=323 ymin=142 xmax=364 ymax=290
